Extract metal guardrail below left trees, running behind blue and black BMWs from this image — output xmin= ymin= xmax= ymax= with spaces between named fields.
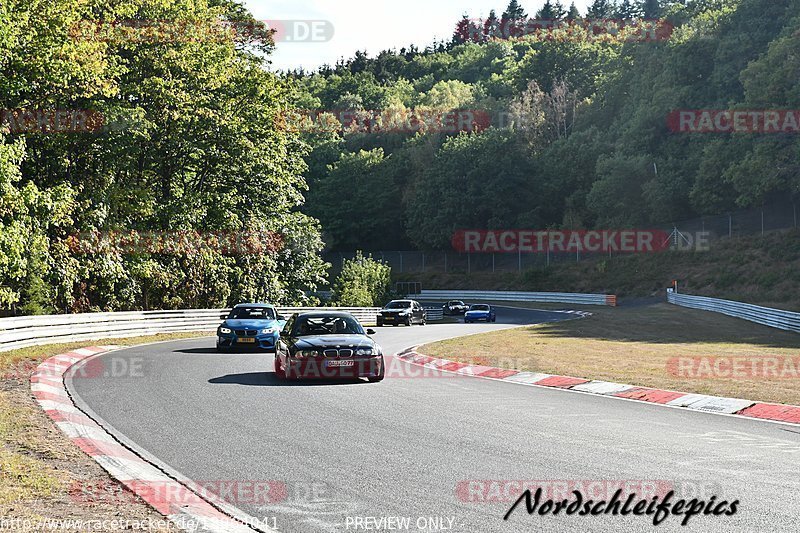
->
xmin=0 ymin=307 xmax=379 ymax=352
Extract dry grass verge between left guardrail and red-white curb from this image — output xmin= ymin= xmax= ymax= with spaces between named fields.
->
xmin=0 ymin=333 xmax=208 ymax=531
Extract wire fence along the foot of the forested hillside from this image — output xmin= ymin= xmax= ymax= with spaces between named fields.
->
xmin=324 ymin=198 xmax=798 ymax=278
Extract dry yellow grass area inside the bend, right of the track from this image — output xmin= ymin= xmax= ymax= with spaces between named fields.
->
xmin=420 ymin=304 xmax=800 ymax=405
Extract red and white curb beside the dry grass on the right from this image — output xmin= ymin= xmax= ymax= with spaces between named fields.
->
xmin=397 ymin=347 xmax=800 ymax=424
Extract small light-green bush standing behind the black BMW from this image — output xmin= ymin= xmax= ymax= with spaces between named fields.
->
xmin=332 ymin=252 xmax=392 ymax=307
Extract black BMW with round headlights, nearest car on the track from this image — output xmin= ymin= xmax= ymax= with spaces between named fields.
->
xmin=275 ymin=311 xmax=385 ymax=382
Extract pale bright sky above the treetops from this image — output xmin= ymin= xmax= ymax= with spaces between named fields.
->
xmin=241 ymin=0 xmax=591 ymax=70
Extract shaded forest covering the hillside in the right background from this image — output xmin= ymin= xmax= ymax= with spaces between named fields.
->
xmin=296 ymin=0 xmax=800 ymax=250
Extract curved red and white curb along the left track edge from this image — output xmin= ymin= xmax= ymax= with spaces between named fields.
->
xmin=31 ymin=346 xmax=263 ymax=533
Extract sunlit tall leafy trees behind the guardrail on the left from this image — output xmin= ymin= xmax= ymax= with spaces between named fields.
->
xmin=0 ymin=0 xmax=325 ymax=313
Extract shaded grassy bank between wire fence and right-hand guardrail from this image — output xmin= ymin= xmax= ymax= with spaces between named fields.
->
xmin=392 ymin=230 xmax=800 ymax=311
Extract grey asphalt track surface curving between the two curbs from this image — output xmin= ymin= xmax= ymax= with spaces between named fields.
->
xmin=69 ymin=308 xmax=800 ymax=533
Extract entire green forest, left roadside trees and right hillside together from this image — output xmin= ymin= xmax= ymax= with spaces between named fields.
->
xmin=0 ymin=0 xmax=800 ymax=314
